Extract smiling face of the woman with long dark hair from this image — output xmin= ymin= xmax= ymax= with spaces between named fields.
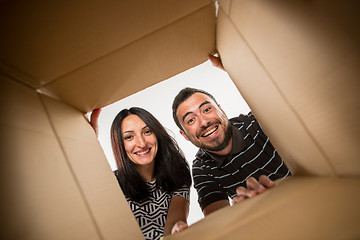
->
xmin=121 ymin=114 xmax=158 ymax=166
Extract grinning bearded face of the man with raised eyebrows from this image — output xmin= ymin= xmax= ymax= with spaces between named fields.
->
xmin=176 ymin=93 xmax=231 ymax=152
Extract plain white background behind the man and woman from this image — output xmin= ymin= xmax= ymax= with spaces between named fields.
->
xmin=95 ymin=61 xmax=251 ymax=225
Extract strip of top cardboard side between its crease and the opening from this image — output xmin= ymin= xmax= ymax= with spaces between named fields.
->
xmin=40 ymin=5 xmax=215 ymax=111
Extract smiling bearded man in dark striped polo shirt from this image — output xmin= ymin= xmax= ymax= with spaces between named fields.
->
xmin=173 ymin=57 xmax=290 ymax=216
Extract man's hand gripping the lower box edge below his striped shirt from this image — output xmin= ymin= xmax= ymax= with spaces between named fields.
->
xmin=232 ymin=175 xmax=275 ymax=204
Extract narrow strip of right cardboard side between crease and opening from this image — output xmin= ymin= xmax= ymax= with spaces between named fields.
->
xmin=217 ymin=6 xmax=335 ymax=175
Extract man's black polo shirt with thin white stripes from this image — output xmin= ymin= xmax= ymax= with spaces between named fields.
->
xmin=192 ymin=113 xmax=290 ymax=209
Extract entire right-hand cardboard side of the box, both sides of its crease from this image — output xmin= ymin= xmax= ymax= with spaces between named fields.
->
xmin=217 ymin=1 xmax=360 ymax=176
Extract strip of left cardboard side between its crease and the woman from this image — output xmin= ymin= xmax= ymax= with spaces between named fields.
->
xmin=42 ymin=96 xmax=143 ymax=239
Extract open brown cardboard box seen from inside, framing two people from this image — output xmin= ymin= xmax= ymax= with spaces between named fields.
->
xmin=0 ymin=0 xmax=360 ymax=239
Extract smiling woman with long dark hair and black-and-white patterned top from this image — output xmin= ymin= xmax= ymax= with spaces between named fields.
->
xmin=111 ymin=107 xmax=191 ymax=239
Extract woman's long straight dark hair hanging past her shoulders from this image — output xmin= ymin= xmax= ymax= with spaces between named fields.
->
xmin=111 ymin=107 xmax=191 ymax=202
